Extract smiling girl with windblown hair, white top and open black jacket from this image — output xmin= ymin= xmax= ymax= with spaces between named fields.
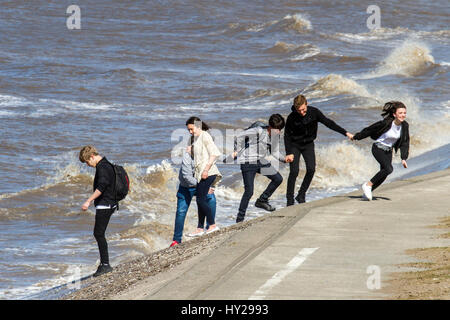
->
xmin=353 ymin=101 xmax=409 ymax=200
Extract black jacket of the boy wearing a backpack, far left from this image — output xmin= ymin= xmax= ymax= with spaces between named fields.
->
xmin=94 ymin=157 xmax=117 ymax=206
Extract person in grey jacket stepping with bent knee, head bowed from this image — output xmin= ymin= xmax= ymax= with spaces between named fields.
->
xmin=233 ymin=114 xmax=292 ymax=223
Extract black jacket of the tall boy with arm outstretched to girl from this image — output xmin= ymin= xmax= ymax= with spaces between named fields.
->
xmin=284 ymin=106 xmax=347 ymax=154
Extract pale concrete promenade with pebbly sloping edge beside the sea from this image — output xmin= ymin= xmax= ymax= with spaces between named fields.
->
xmin=61 ymin=169 xmax=450 ymax=300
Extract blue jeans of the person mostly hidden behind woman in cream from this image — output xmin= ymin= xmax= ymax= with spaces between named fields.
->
xmin=173 ymin=186 xmax=216 ymax=243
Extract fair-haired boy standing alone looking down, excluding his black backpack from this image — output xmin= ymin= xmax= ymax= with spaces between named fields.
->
xmin=79 ymin=146 xmax=117 ymax=277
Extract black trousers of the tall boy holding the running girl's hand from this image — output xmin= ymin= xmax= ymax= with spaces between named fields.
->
xmin=286 ymin=142 xmax=316 ymax=200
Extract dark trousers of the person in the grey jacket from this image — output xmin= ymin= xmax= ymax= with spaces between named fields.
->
xmin=238 ymin=163 xmax=283 ymax=220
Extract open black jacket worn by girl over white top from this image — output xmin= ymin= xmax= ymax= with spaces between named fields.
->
xmin=353 ymin=118 xmax=409 ymax=160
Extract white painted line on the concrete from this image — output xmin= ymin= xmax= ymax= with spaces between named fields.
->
xmin=248 ymin=248 xmax=319 ymax=300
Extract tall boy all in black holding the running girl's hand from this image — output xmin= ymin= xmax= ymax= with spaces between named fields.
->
xmin=284 ymin=95 xmax=353 ymax=206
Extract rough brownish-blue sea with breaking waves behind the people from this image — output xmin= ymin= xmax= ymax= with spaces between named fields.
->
xmin=0 ymin=0 xmax=450 ymax=299
